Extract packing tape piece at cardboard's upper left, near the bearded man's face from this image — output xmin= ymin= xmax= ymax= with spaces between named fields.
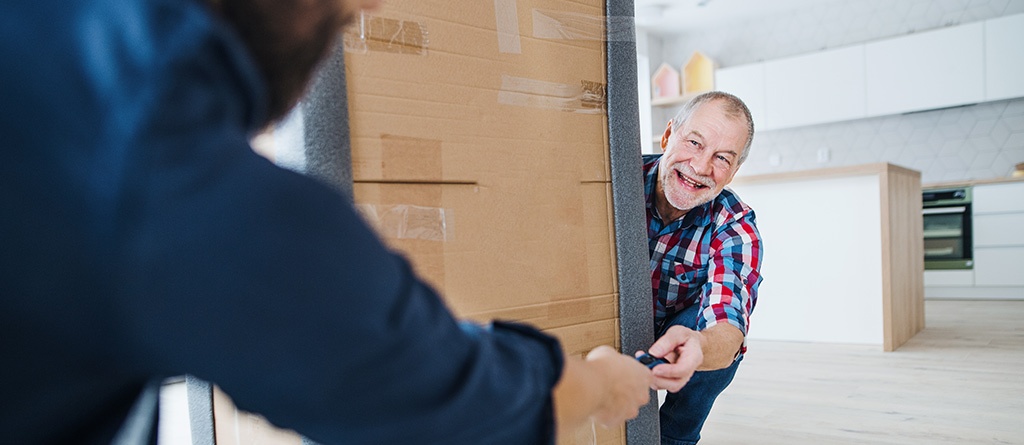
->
xmin=344 ymin=12 xmax=430 ymax=55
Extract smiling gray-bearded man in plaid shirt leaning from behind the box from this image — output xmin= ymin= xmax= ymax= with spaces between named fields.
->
xmin=643 ymin=92 xmax=762 ymax=445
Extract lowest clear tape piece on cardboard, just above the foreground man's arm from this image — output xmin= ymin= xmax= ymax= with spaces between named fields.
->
xmin=355 ymin=204 xmax=455 ymax=242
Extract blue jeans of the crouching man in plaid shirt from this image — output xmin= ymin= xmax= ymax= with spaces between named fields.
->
xmin=657 ymin=305 xmax=742 ymax=445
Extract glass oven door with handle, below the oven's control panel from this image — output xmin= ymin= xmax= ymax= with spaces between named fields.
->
xmin=923 ymin=204 xmax=974 ymax=270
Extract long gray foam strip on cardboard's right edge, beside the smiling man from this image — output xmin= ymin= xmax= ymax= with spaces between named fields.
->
xmin=605 ymin=0 xmax=660 ymax=445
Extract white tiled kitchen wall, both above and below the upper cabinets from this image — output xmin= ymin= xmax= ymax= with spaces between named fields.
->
xmin=648 ymin=0 xmax=1024 ymax=184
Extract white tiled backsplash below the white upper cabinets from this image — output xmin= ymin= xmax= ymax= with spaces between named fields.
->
xmin=739 ymin=99 xmax=1024 ymax=184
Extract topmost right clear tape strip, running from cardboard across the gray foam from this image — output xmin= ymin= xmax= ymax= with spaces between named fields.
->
xmin=532 ymin=9 xmax=636 ymax=42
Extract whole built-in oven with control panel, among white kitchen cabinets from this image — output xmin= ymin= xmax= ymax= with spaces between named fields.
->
xmin=922 ymin=187 xmax=974 ymax=270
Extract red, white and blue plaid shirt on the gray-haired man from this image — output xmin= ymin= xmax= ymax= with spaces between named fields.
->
xmin=643 ymin=154 xmax=761 ymax=353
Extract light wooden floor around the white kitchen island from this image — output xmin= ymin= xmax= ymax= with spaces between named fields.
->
xmin=700 ymin=300 xmax=1024 ymax=445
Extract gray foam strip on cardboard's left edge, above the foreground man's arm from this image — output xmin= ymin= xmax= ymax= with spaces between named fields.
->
xmin=301 ymin=38 xmax=352 ymax=202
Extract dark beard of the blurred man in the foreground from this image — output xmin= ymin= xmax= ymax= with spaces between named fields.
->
xmin=215 ymin=0 xmax=353 ymax=123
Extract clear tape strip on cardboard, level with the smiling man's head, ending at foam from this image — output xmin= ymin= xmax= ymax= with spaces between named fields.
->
xmin=498 ymin=75 xmax=607 ymax=115
